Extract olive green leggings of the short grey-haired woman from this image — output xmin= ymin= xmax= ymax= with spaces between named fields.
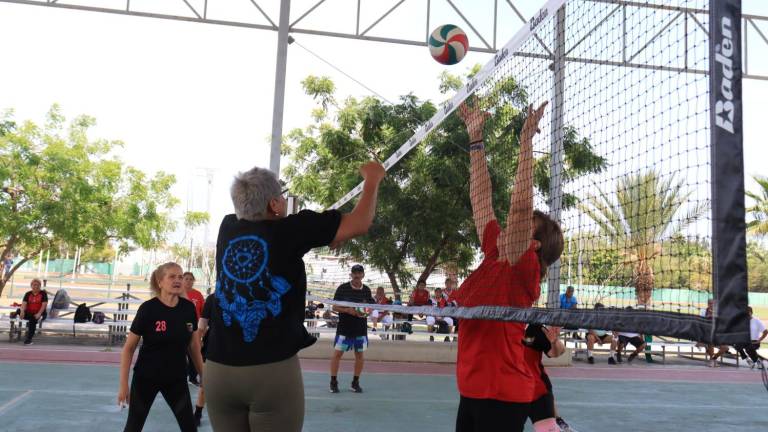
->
xmin=203 ymin=356 xmax=304 ymax=432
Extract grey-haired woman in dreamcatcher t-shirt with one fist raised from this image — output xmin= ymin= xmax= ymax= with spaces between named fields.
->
xmin=203 ymin=162 xmax=385 ymax=432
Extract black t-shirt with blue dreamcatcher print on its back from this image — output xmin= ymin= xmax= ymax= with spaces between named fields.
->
xmin=206 ymin=210 xmax=341 ymax=366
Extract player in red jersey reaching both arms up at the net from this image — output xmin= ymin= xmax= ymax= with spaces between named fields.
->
xmin=451 ymin=99 xmax=564 ymax=432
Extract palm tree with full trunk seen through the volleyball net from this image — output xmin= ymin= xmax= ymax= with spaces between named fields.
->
xmin=579 ymin=171 xmax=709 ymax=305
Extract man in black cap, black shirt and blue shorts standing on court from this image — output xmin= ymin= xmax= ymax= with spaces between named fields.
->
xmin=331 ymin=264 xmax=375 ymax=393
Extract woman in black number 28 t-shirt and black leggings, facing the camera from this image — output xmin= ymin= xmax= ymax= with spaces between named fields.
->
xmin=117 ymin=262 xmax=203 ymax=432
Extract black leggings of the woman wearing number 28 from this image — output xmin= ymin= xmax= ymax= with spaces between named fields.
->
xmin=123 ymin=374 xmax=197 ymax=432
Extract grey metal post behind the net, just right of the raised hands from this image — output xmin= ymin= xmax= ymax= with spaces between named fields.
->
xmin=548 ymin=3 xmax=567 ymax=308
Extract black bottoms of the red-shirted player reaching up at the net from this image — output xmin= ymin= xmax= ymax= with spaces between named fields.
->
xmin=456 ymin=396 xmax=531 ymax=432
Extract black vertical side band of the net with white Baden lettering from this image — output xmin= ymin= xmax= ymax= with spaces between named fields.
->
xmin=709 ymin=0 xmax=749 ymax=345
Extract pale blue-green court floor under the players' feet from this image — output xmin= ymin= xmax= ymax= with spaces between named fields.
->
xmin=0 ymin=360 xmax=768 ymax=432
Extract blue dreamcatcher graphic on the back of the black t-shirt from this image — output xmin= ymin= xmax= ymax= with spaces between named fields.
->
xmin=216 ymin=235 xmax=291 ymax=342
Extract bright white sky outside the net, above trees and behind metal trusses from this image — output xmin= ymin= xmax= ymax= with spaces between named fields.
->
xmin=0 ymin=0 xmax=768 ymax=258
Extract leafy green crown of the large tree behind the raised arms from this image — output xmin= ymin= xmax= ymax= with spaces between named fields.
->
xmin=284 ymin=75 xmax=605 ymax=293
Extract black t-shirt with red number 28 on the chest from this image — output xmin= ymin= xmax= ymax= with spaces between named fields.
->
xmin=131 ymin=297 xmax=197 ymax=381
